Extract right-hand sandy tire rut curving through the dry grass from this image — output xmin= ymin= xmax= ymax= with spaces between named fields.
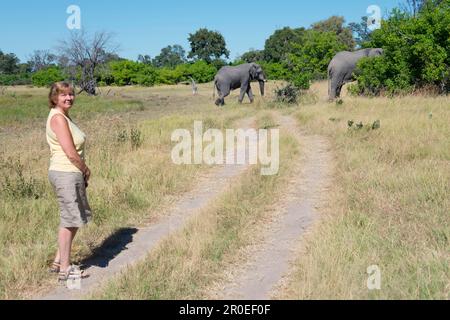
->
xmin=206 ymin=113 xmax=333 ymax=300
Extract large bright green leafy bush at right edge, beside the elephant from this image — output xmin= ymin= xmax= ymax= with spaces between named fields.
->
xmin=351 ymin=0 xmax=450 ymax=95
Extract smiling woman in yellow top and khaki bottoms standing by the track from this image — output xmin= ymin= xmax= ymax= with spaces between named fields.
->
xmin=46 ymin=82 xmax=92 ymax=281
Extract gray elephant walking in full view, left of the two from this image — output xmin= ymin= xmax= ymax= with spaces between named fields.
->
xmin=214 ymin=63 xmax=267 ymax=106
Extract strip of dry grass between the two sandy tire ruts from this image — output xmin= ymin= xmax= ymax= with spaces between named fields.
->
xmin=89 ymin=114 xmax=299 ymax=300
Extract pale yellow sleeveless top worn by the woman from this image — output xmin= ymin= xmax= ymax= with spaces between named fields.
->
xmin=46 ymin=109 xmax=86 ymax=172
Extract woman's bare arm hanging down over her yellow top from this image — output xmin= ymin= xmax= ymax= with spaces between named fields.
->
xmin=50 ymin=114 xmax=91 ymax=180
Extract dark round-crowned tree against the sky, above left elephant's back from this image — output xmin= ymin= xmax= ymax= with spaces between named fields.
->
xmin=188 ymin=28 xmax=230 ymax=63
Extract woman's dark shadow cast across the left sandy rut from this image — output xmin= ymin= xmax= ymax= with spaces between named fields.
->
xmin=80 ymin=228 xmax=138 ymax=269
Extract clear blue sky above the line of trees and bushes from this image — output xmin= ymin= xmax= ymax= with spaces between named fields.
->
xmin=0 ymin=0 xmax=403 ymax=61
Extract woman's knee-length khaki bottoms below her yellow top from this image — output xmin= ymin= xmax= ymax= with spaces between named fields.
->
xmin=48 ymin=171 xmax=92 ymax=228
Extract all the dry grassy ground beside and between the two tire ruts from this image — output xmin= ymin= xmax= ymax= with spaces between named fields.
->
xmin=0 ymin=83 xmax=450 ymax=299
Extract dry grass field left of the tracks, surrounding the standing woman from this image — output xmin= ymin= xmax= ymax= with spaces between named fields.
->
xmin=0 ymin=86 xmax=268 ymax=299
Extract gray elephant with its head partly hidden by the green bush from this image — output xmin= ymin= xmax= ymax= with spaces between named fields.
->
xmin=328 ymin=48 xmax=384 ymax=100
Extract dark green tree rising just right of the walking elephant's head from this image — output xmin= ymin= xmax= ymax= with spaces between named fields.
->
xmin=264 ymin=27 xmax=305 ymax=63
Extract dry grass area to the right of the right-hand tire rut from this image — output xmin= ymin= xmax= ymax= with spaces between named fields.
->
xmin=281 ymin=83 xmax=450 ymax=299
